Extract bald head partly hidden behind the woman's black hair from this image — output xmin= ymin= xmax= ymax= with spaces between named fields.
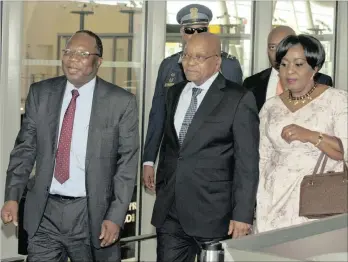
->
xmin=267 ymin=25 xmax=296 ymax=68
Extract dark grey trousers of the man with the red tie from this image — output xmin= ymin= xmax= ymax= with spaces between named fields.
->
xmin=26 ymin=196 xmax=121 ymax=262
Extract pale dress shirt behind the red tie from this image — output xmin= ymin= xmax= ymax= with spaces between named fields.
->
xmin=50 ymin=78 xmax=96 ymax=197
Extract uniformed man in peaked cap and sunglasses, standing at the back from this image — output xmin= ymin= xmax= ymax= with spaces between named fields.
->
xmin=143 ymin=4 xmax=243 ymax=191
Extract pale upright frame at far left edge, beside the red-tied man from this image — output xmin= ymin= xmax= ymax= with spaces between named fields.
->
xmin=0 ymin=1 xmax=23 ymax=259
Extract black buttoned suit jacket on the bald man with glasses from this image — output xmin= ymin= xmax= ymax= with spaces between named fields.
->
xmin=152 ymin=74 xmax=259 ymax=238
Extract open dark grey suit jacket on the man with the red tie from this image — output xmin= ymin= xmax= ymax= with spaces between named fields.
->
xmin=5 ymin=76 xmax=138 ymax=247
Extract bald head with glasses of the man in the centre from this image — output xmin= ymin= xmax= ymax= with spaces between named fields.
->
xmin=182 ymin=32 xmax=221 ymax=86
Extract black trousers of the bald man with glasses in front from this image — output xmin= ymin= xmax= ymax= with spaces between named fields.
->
xmin=156 ymin=203 xmax=224 ymax=262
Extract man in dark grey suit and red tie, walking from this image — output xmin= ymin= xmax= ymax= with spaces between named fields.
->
xmin=1 ymin=30 xmax=138 ymax=262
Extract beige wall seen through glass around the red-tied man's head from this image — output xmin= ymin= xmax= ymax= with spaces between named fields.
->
xmin=22 ymin=1 xmax=142 ymax=102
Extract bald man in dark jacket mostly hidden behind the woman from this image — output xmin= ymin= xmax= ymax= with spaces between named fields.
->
xmin=243 ymin=26 xmax=332 ymax=111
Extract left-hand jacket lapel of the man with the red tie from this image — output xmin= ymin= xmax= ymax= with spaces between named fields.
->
xmin=47 ymin=77 xmax=67 ymax=155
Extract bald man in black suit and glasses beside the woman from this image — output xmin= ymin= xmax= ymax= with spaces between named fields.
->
xmin=152 ymin=33 xmax=259 ymax=262
